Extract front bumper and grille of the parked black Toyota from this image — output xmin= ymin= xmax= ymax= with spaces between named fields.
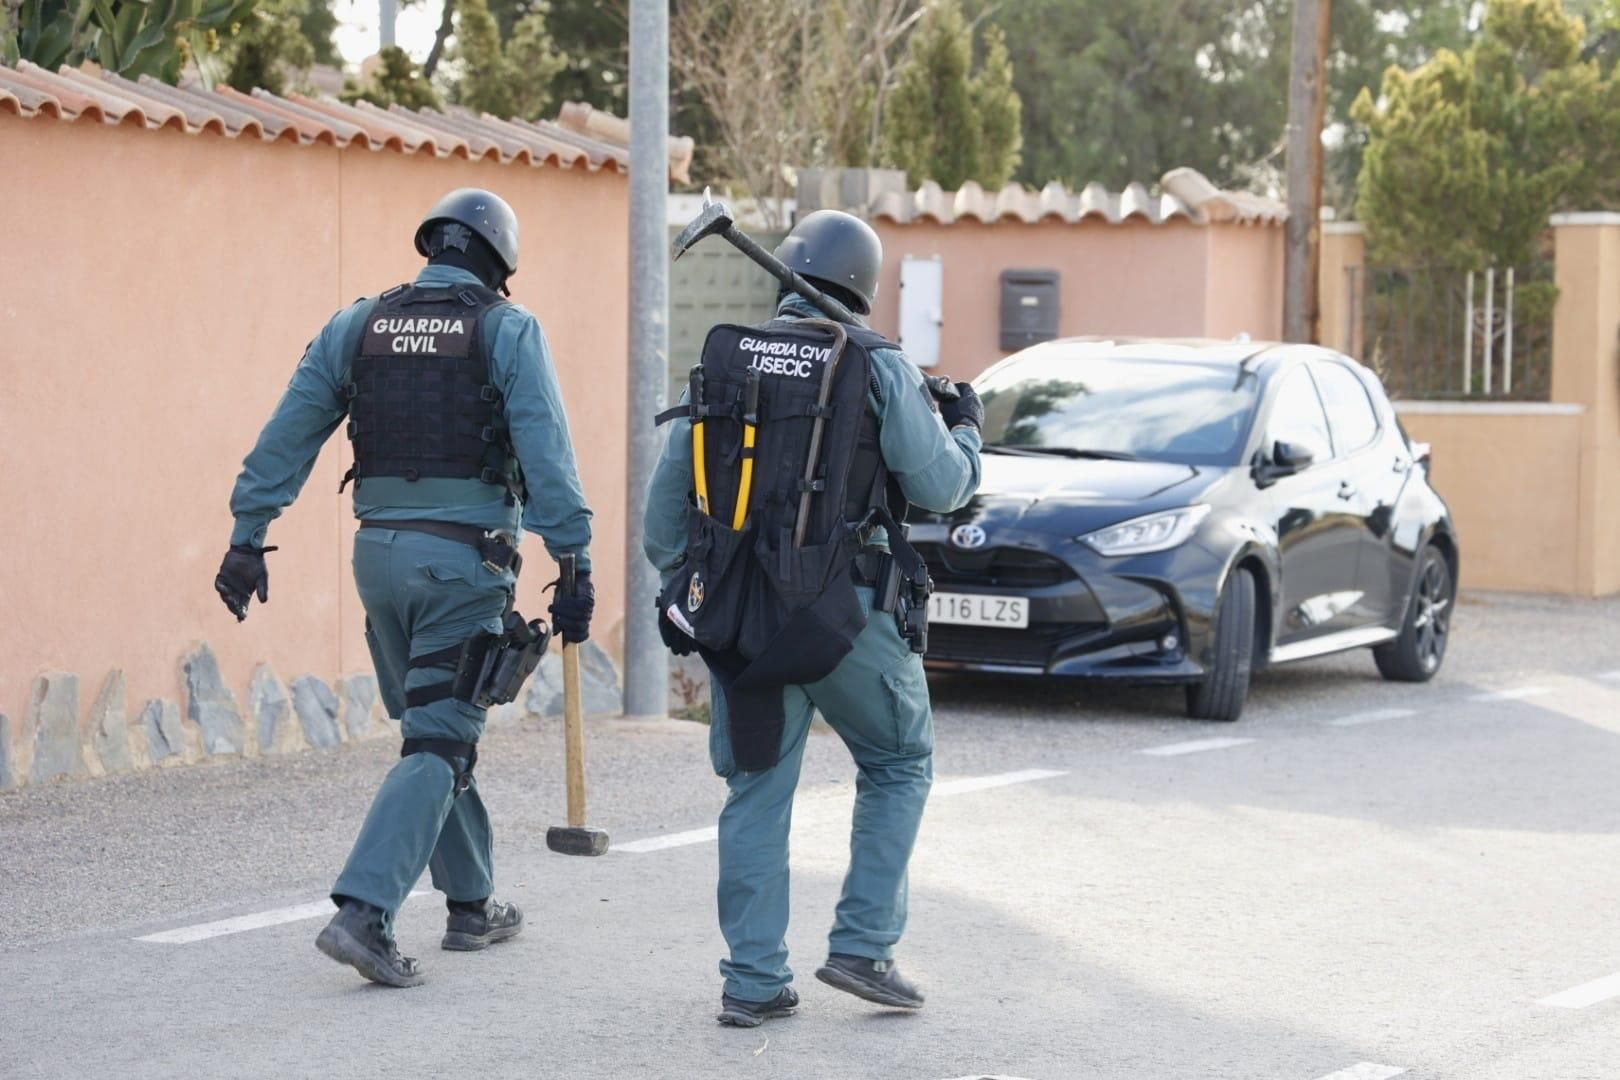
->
xmin=912 ymin=526 xmax=1220 ymax=683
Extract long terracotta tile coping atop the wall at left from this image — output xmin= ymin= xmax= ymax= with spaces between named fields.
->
xmin=0 ymin=62 xmax=692 ymax=180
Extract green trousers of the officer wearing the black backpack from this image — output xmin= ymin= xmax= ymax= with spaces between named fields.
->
xmin=710 ymin=589 xmax=933 ymax=1001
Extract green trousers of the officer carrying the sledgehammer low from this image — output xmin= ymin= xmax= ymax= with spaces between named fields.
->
xmin=332 ymin=528 xmax=515 ymax=920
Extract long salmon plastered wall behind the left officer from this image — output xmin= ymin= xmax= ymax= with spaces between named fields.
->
xmin=0 ymin=113 xmax=627 ymax=755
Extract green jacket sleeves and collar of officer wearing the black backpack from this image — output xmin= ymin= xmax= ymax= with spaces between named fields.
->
xmin=645 ymin=296 xmax=980 ymax=583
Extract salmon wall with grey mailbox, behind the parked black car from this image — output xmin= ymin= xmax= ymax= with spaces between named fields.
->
xmin=872 ymin=219 xmax=1283 ymax=379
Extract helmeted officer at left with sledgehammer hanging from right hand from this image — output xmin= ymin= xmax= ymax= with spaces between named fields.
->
xmin=214 ymin=188 xmax=593 ymax=986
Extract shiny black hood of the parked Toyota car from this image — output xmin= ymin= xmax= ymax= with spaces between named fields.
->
xmin=936 ymin=453 xmax=1230 ymax=536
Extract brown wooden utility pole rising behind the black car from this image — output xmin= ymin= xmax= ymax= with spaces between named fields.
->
xmin=1283 ymin=0 xmax=1333 ymax=342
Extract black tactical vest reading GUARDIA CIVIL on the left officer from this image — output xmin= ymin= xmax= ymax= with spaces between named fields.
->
xmin=339 ymin=285 xmax=523 ymax=502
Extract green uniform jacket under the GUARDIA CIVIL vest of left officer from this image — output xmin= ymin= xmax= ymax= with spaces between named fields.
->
xmin=230 ymin=266 xmax=591 ymax=572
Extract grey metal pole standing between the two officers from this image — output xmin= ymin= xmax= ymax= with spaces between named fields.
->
xmin=624 ymin=0 xmax=669 ymax=716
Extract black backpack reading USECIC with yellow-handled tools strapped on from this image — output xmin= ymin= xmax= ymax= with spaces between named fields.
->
xmin=658 ymin=319 xmax=920 ymax=769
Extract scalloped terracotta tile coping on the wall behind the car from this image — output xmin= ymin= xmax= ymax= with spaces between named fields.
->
xmin=868 ymin=168 xmax=1288 ymax=225
